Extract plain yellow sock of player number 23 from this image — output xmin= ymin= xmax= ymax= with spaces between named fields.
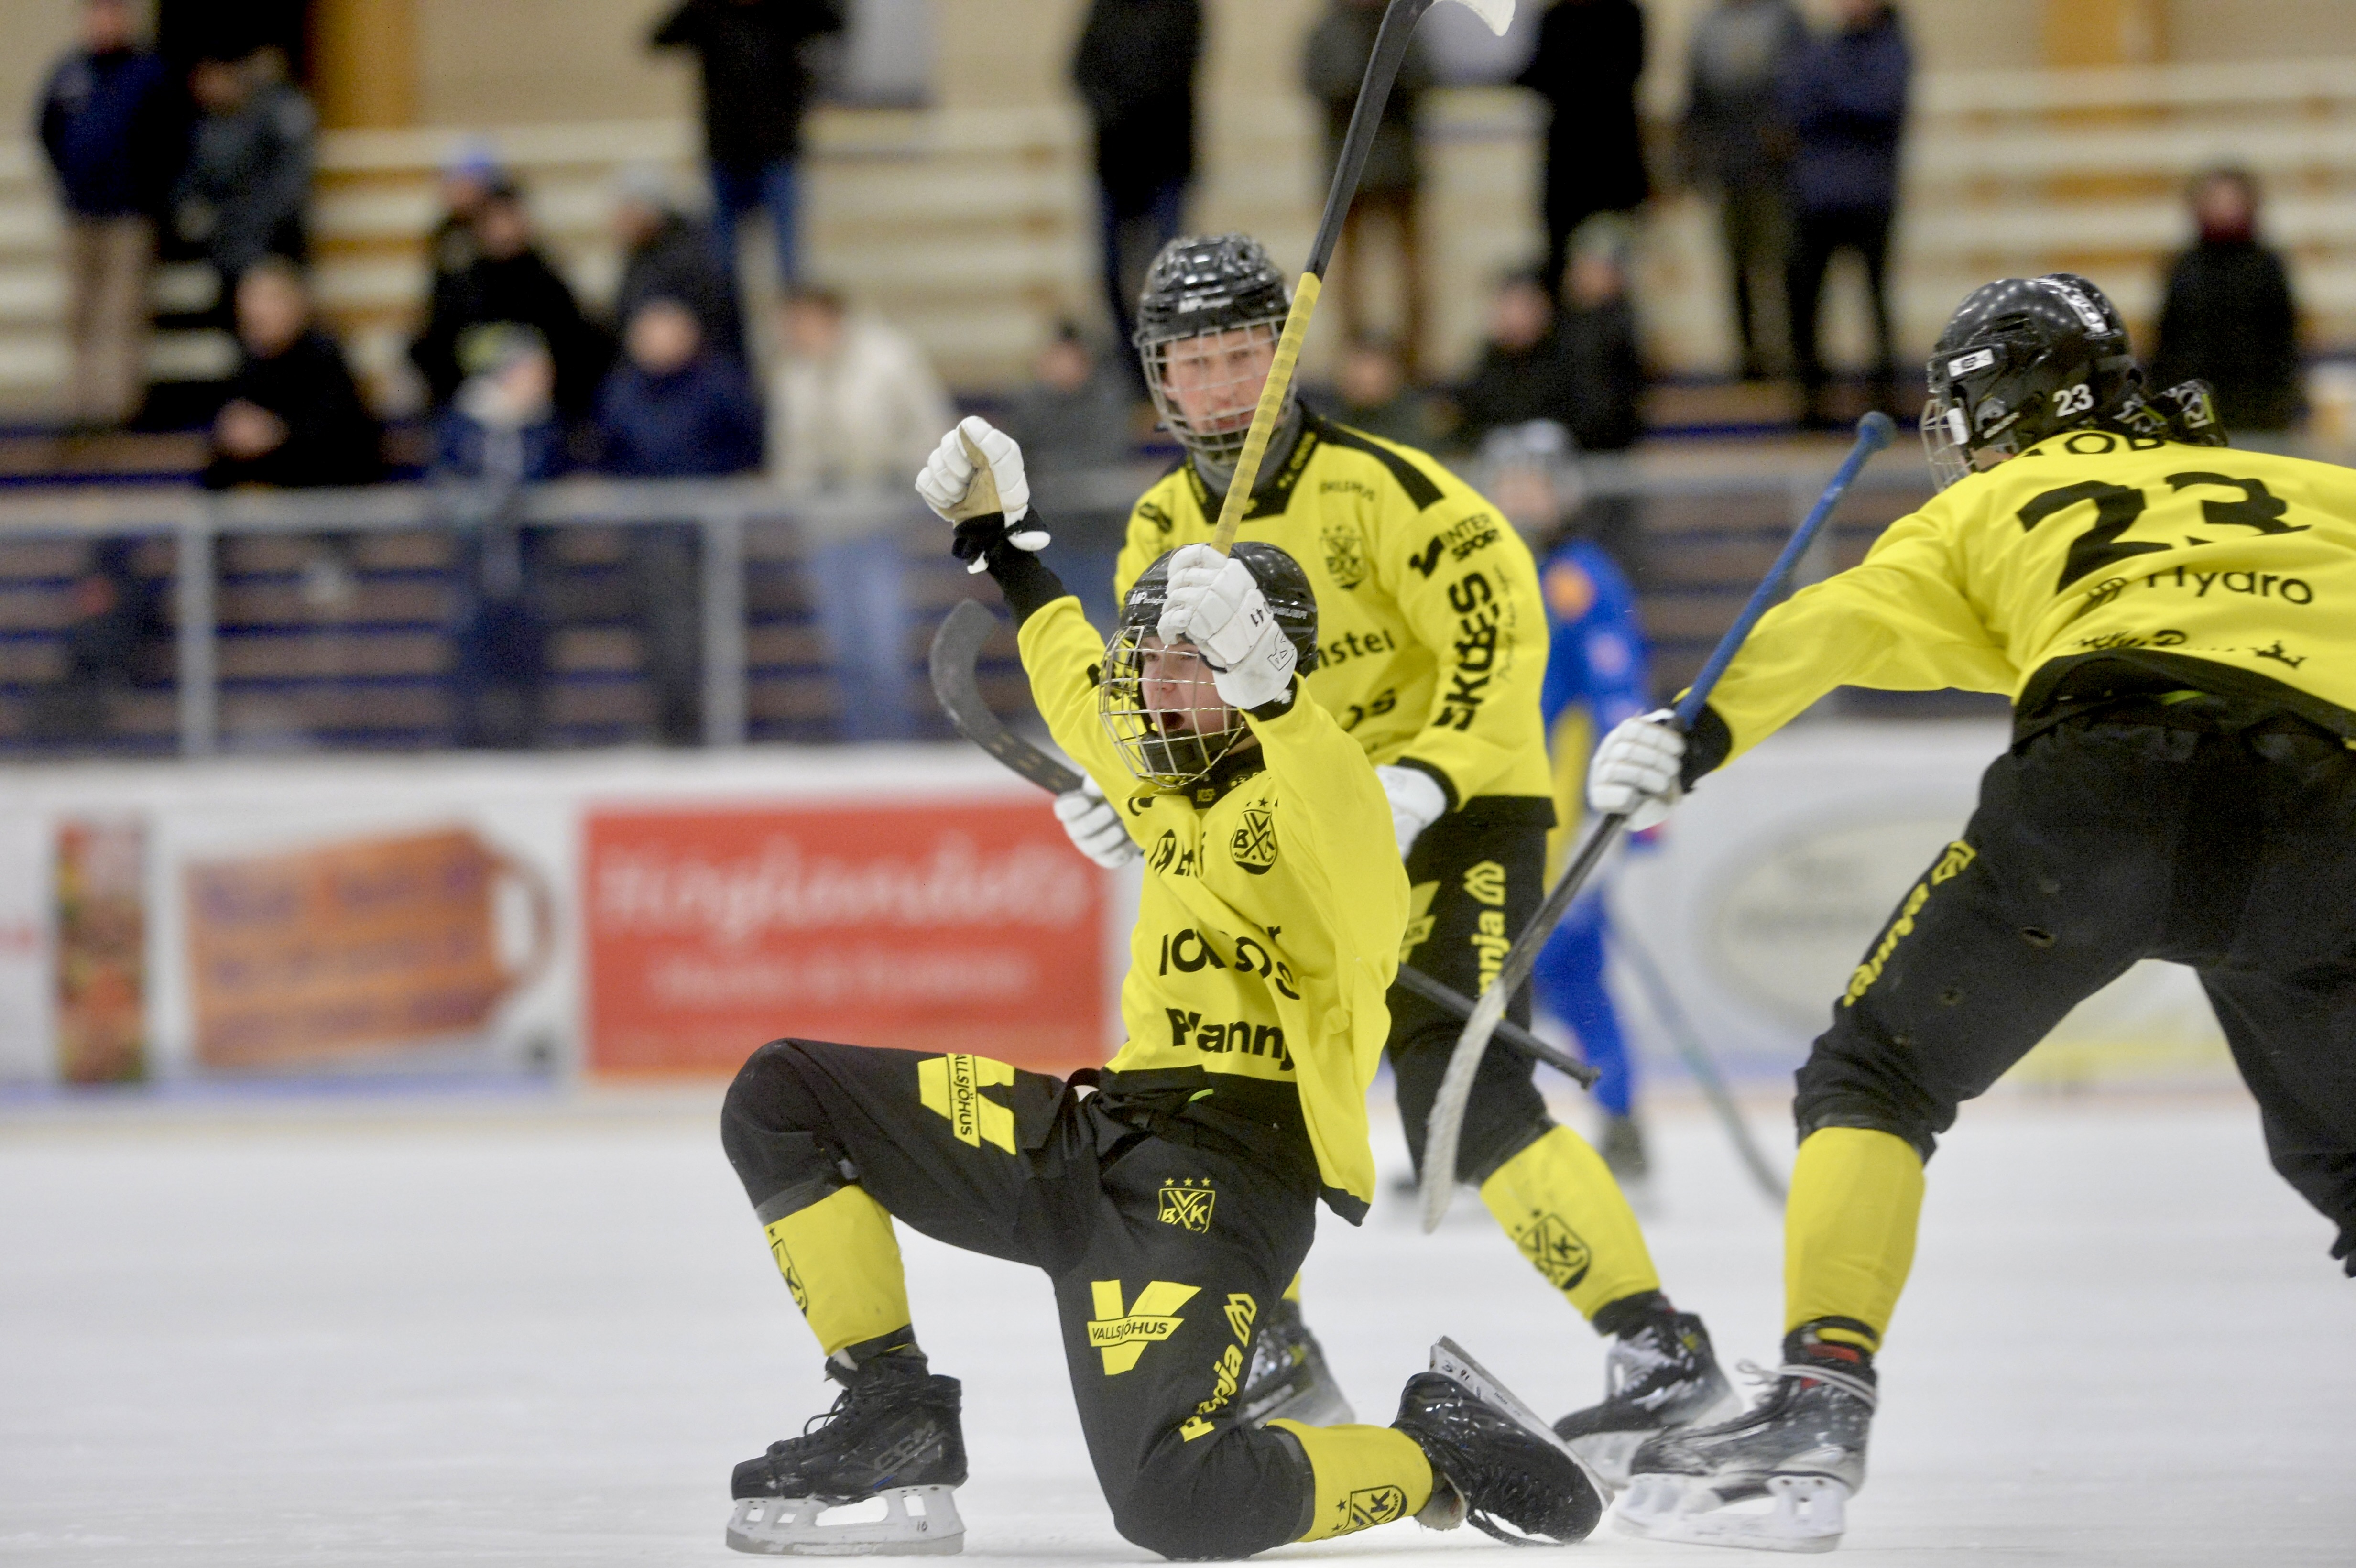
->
xmin=1783 ymin=1128 xmax=1922 ymax=1351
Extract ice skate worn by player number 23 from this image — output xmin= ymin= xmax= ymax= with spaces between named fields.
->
xmin=1616 ymin=1361 xmax=1876 ymax=1552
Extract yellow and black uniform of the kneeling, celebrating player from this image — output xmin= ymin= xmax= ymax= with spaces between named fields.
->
xmin=723 ymin=551 xmax=1432 ymax=1558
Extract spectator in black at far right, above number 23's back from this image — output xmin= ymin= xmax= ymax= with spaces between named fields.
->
xmin=2151 ymin=170 xmax=2300 ymax=433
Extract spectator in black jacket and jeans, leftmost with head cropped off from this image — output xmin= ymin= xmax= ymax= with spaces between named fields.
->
xmin=650 ymin=0 xmax=843 ymax=283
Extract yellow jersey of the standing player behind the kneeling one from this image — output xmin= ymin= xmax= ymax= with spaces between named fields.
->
xmin=1114 ymin=412 xmax=1553 ymax=810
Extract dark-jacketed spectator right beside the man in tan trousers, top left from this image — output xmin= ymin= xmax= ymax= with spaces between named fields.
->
xmin=172 ymin=49 xmax=316 ymax=294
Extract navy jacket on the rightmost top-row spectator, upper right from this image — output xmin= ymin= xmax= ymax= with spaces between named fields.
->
xmin=1779 ymin=7 xmax=1913 ymax=212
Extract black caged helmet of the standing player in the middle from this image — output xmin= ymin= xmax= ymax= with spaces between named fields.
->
xmin=1135 ymin=233 xmax=1291 ymax=471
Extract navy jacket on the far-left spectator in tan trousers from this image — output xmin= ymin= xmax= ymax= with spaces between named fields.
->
xmin=40 ymin=49 xmax=188 ymax=217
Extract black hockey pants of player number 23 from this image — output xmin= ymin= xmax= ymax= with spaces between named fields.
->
xmin=1793 ymin=699 xmax=2356 ymax=1274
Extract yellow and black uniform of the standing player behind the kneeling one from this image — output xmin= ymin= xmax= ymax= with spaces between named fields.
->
xmin=1114 ymin=414 xmax=1658 ymax=1318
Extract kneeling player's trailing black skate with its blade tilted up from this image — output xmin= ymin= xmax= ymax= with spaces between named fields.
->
xmin=1392 ymin=1339 xmax=1604 ymax=1547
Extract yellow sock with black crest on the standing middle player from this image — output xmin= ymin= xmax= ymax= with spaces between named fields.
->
xmin=1480 ymin=1128 xmax=1661 ymax=1318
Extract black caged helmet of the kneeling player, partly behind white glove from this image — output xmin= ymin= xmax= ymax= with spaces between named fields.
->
xmin=1096 ymin=539 xmax=1317 ymax=789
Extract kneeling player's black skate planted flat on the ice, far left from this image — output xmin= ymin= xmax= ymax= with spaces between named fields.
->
xmin=728 ymin=1351 xmax=966 ymax=1556
